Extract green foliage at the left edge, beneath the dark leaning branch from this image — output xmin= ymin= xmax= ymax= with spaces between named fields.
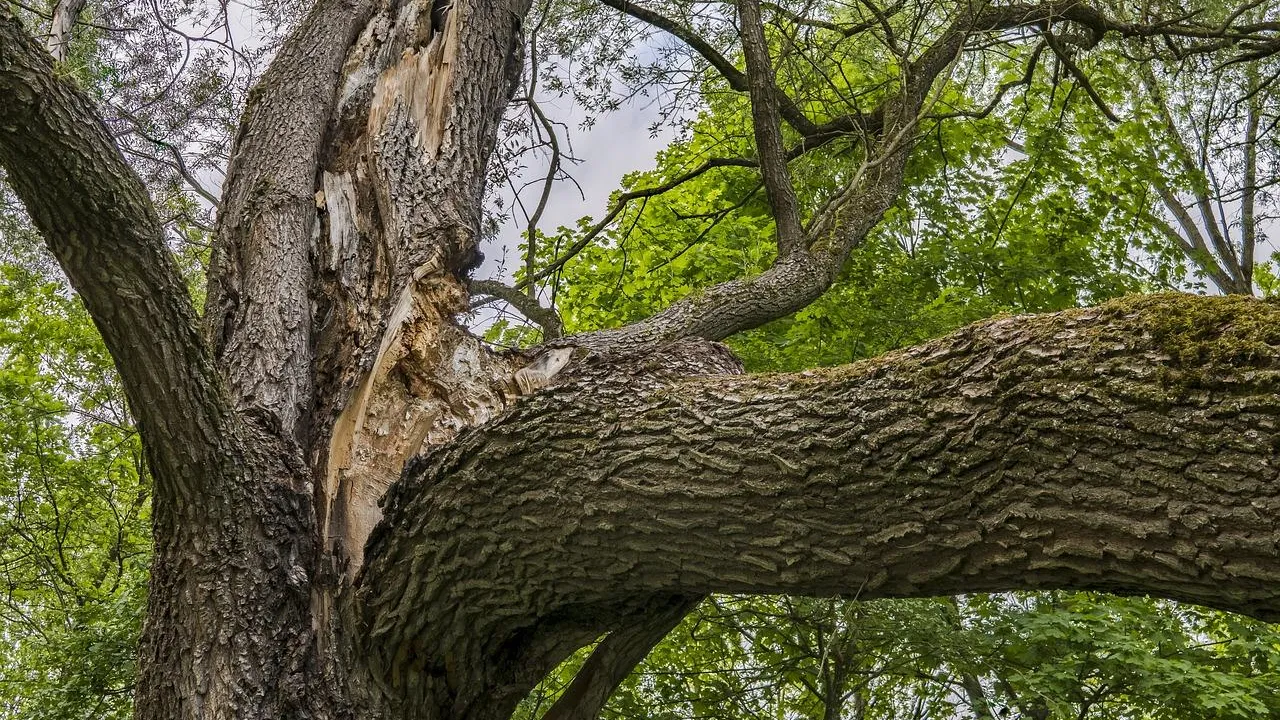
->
xmin=0 ymin=214 xmax=150 ymax=720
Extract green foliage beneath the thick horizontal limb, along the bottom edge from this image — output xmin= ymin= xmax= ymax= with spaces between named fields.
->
xmin=517 ymin=592 xmax=1280 ymax=720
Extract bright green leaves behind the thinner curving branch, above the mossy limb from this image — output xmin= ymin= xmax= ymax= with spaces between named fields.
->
xmin=555 ymin=46 xmax=1185 ymax=370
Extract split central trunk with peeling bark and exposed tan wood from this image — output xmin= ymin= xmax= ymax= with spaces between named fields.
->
xmin=315 ymin=0 xmax=527 ymax=578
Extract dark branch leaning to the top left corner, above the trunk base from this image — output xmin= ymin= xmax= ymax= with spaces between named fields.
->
xmin=0 ymin=8 xmax=233 ymax=502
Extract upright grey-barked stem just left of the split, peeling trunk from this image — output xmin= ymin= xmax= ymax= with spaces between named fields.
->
xmin=205 ymin=0 xmax=374 ymax=437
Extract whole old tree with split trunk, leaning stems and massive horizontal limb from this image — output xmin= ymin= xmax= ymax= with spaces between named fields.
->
xmin=0 ymin=0 xmax=1280 ymax=719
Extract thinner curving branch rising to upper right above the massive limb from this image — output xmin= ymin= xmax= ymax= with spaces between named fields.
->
xmin=567 ymin=0 xmax=1280 ymax=350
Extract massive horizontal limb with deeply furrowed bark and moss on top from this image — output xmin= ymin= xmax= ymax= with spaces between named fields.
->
xmin=356 ymin=295 xmax=1280 ymax=712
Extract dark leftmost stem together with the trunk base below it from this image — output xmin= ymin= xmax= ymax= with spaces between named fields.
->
xmin=0 ymin=8 xmax=323 ymax=719
